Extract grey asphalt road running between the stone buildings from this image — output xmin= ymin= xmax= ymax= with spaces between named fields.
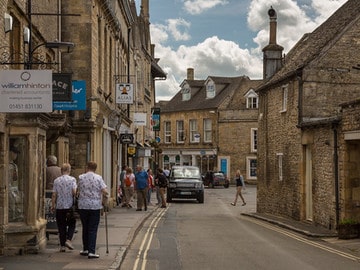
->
xmin=120 ymin=186 xmax=360 ymax=270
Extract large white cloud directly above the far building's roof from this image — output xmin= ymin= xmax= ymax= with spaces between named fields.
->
xmin=155 ymin=36 xmax=262 ymax=100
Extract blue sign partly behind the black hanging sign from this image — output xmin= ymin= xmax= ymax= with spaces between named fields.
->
xmin=53 ymin=81 xmax=86 ymax=111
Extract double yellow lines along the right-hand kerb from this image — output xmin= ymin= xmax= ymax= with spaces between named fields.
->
xmin=245 ymin=217 xmax=360 ymax=261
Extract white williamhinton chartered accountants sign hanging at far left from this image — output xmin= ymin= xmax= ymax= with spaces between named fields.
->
xmin=0 ymin=70 xmax=53 ymax=113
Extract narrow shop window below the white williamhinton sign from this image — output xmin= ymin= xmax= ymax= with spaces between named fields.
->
xmin=8 ymin=136 xmax=27 ymax=222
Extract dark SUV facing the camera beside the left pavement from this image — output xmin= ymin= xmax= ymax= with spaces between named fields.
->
xmin=166 ymin=166 xmax=204 ymax=203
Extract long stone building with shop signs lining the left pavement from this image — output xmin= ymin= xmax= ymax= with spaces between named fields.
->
xmin=0 ymin=0 xmax=166 ymax=255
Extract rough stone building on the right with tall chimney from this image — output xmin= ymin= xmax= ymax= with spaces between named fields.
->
xmin=257 ymin=0 xmax=360 ymax=229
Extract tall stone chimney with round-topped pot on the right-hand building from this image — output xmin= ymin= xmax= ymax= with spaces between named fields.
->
xmin=263 ymin=7 xmax=284 ymax=80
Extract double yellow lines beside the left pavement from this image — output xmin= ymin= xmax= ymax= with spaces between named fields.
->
xmin=133 ymin=208 xmax=168 ymax=270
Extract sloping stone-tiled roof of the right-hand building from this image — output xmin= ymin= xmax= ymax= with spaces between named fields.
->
xmin=257 ymin=0 xmax=360 ymax=91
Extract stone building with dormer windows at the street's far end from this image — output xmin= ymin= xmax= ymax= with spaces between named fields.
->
xmin=158 ymin=68 xmax=260 ymax=184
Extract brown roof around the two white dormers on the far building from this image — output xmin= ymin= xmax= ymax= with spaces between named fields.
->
xmin=161 ymin=76 xmax=250 ymax=113
